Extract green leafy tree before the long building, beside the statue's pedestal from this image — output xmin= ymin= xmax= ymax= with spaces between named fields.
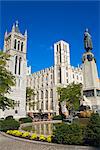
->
xmin=57 ymin=83 xmax=82 ymax=113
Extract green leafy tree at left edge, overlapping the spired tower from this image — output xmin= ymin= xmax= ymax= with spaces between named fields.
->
xmin=0 ymin=51 xmax=15 ymax=110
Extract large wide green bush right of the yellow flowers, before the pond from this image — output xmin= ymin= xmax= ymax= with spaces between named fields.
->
xmin=53 ymin=123 xmax=83 ymax=145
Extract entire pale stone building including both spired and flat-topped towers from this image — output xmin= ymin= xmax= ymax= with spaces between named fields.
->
xmin=0 ymin=22 xmax=99 ymax=118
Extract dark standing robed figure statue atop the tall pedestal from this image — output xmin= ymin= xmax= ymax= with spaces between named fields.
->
xmin=84 ymin=29 xmax=93 ymax=52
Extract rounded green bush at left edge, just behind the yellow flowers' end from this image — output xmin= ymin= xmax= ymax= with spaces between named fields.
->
xmin=0 ymin=119 xmax=20 ymax=132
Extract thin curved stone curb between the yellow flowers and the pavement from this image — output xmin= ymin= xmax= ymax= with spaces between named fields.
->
xmin=0 ymin=132 xmax=99 ymax=150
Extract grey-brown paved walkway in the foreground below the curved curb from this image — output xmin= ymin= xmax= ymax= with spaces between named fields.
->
xmin=0 ymin=134 xmax=95 ymax=150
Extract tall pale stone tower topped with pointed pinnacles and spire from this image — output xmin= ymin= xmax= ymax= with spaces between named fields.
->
xmin=4 ymin=21 xmax=27 ymax=118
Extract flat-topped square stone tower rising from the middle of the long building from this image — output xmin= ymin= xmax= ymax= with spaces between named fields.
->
xmin=54 ymin=40 xmax=70 ymax=85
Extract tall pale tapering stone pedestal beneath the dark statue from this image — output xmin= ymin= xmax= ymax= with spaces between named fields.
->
xmin=82 ymin=51 xmax=100 ymax=110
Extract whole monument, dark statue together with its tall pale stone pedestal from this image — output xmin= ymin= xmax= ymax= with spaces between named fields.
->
xmin=82 ymin=29 xmax=100 ymax=111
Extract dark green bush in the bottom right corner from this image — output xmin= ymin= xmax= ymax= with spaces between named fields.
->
xmin=84 ymin=113 xmax=100 ymax=146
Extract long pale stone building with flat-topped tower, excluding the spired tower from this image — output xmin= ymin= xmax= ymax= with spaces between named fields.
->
xmin=27 ymin=40 xmax=83 ymax=115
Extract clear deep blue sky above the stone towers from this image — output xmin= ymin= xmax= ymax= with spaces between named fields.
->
xmin=0 ymin=1 xmax=100 ymax=76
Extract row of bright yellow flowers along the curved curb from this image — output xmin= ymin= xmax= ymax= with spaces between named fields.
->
xmin=6 ymin=130 xmax=52 ymax=143
